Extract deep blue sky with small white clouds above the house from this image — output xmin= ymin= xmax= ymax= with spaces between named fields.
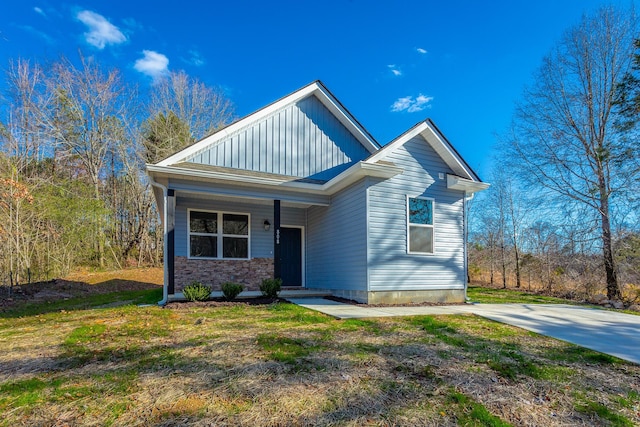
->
xmin=0 ymin=0 xmax=630 ymax=177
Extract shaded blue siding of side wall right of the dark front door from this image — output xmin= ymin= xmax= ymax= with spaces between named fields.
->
xmin=307 ymin=180 xmax=367 ymax=291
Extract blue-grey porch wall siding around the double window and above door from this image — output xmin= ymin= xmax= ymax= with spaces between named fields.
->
xmin=175 ymin=196 xmax=306 ymax=258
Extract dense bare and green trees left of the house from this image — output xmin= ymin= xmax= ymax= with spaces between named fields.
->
xmin=0 ymin=55 xmax=233 ymax=286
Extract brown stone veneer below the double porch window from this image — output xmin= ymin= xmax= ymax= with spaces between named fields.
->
xmin=174 ymin=256 xmax=273 ymax=293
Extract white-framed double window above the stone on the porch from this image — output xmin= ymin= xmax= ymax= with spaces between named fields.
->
xmin=188 ymin=210 xmax=249 ymax=259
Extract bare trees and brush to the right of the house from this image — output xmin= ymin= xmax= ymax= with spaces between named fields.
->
xmin=470 ymin=7 xmax=640 ymax=303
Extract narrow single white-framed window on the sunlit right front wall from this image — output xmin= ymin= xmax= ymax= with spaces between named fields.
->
xmin=407 ymin=197 xmax=435 ymax=254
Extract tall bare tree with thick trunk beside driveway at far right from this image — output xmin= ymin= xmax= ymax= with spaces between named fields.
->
xmin=507 ymin=7 xmax=637 ymax=299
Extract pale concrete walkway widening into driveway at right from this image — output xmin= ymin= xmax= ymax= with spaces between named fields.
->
xmin=289 ymin=298 xmax=640 ymax=364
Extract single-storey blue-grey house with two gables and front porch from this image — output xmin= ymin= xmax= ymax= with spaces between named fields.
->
xmin=147 ymin=81 xmax=488 ymax=304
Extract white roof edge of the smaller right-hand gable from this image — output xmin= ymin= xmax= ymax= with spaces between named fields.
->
xmin=365 ymin=119 xmax=482 ymax=182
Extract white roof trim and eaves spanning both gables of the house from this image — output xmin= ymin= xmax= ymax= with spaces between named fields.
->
xmin=146 ymin=81 xmax=489 ymax=201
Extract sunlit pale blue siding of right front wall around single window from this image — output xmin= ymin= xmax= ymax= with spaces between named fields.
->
xmin=367 ymin=136 xmax=465 ymax=291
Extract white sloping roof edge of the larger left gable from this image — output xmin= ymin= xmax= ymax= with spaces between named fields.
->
xmin=156 ymin=80 xmax=380 ymax=166
